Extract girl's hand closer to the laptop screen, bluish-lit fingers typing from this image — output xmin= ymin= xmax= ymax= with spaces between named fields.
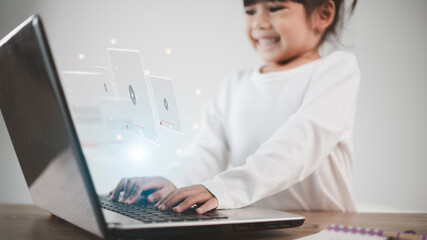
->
xmin=110 ymin=177 xmax=176 ymax=204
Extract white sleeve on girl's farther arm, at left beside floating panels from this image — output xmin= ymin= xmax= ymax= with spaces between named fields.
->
xmin=165 ymin=76 xmax=232 ymax=187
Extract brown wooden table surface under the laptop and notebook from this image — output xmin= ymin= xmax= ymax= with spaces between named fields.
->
xmin=0 ymin=204 xmax=427 ymax=240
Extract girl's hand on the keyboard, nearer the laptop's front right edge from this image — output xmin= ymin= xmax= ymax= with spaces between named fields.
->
xmin=154 ymin=185 xmax=218 ymax=214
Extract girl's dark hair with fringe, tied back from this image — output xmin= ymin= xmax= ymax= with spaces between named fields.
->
xmin=243 ymin=0 xmax=357 ymax=44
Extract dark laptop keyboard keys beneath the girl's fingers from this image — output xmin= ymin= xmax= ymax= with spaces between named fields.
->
xmin=99 ymin=196 xmax=228 ymax=223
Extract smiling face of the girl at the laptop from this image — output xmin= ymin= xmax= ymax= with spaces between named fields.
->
xmin=245 ymin=1 xmax=321 ymax=64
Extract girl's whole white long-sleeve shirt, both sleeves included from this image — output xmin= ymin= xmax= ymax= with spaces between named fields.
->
xmin=167 ymin=51 xmax=360 ymax=211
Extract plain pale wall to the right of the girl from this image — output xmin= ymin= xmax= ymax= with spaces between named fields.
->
xmin=354 ymin=0 xmax=427 ymax=212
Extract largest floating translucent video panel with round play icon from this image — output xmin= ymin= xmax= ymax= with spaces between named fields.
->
xmin=107 ymin=48 xmax=159 ymax=144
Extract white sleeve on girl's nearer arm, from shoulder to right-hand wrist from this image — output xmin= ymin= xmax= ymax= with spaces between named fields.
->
xmin=202 ymin=55 xmax=360 ymax=209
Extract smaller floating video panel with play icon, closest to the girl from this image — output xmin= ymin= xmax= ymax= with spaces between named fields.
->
xmin=150 ymin=76 xmax=183 ymax=134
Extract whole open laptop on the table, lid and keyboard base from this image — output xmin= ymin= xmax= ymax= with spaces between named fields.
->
xmin=0 ymin=16 xmax=305 ymax=239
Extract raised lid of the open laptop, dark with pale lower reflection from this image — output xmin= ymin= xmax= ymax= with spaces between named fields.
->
xmin=0 ymin=16 xmax=107 ymax=237
